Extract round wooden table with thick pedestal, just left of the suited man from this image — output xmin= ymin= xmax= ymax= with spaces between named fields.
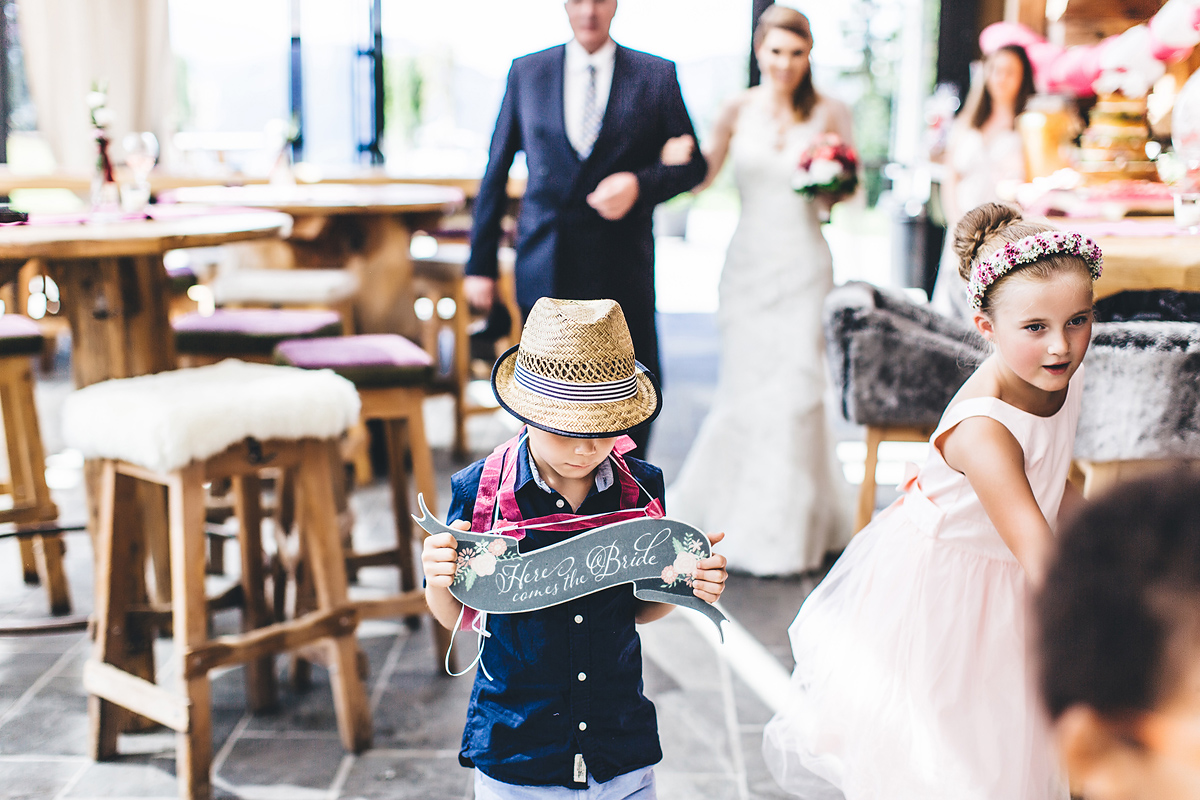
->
xmin=164 ymin=184 xmax=466 ymax=339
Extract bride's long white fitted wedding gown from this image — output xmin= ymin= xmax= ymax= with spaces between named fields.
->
xmin=667 ymin=96 xmax=851 ymax=576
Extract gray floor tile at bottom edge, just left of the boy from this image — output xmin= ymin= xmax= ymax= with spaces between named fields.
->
xmin=338 ymin=752 xmax=474 ymax=800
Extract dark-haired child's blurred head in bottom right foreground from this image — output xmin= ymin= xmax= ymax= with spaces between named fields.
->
xmin=1037 ymin=470 xmax=1200 ymax=800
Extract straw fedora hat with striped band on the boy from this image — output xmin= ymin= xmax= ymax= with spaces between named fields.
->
xmin=492 ymin=297 xmax=662 ymax=439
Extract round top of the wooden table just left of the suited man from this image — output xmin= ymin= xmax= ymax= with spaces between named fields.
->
xmin=163 ymin=184 xmax=466 ymax=216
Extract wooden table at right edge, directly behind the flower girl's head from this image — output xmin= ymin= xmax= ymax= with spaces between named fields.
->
xmin=1050 ymin=217 xmax=1200 ymax=299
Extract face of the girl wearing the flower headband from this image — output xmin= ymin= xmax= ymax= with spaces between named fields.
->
xmin=974 ymin=270 xmax=1092 ymax=396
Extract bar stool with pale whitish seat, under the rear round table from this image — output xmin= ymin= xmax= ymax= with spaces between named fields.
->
xmin=212 ymin=269 xmax=359 ymax=333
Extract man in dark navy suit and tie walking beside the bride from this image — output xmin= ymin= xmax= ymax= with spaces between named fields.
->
xmin=464 ymin=0 xmax=707 ymax=451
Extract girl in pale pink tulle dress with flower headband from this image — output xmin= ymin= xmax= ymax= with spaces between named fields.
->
xmin=763 ymin=203 xmax=1100 ymax=800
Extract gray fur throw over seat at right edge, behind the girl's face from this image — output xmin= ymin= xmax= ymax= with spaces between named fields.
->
xmin=1075 ymin=321 xmax=1200 ymax=461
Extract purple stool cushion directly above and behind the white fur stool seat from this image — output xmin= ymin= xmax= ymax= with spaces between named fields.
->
xmin=173 ymin=308 xmax=342 ymax=355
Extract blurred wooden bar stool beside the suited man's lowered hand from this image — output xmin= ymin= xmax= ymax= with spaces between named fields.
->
xmin=413 ymin=243 xmax=523 ymax=458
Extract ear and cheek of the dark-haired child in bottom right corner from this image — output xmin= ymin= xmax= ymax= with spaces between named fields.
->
xmin=1058 ymin=650 xmax=1200 ymax=800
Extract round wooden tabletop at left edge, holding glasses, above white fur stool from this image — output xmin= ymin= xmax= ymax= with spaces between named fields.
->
xmin=0 ymin=209 xmax=292 ymax=263
